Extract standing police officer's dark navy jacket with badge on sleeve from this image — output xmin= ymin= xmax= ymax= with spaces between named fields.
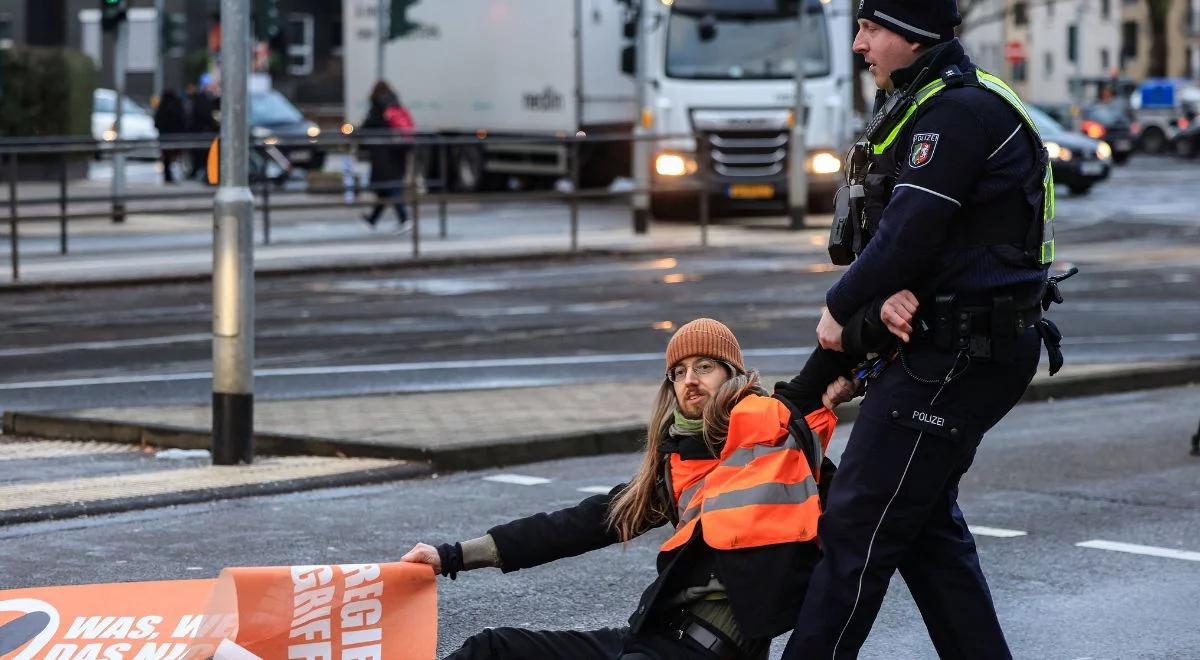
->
xmin=826 ymin=40 xmax=1045 ymax=325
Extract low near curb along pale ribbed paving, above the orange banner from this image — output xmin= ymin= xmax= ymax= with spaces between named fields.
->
xmin=0 ymin=463 xmax=433 ymax=527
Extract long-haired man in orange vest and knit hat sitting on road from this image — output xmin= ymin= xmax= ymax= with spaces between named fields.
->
xmin=402 ymin=318 xmax=878 ymax=660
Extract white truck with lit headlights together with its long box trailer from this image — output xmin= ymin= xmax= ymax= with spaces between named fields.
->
xmin=343 ymin=0 xmax=852 ymax=215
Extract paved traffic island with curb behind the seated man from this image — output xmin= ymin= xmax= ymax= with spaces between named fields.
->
xmin=7 ymin=361 xmax=1200 ymax=524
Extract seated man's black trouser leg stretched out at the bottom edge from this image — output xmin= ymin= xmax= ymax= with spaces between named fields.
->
xmin=445 ymin=628 xmax=766 ymax=660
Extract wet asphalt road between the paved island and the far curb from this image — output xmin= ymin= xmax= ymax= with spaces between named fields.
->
xmin=0 ymin=158 xmax=1200 ymax=410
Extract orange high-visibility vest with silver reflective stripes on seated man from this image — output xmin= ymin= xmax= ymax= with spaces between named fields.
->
xmin=661 ymin=395 xmax=838 ymax=552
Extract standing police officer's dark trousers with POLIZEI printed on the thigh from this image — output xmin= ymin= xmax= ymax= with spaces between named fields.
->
xmin=784 ymin=331 xmax=1040 ymax=660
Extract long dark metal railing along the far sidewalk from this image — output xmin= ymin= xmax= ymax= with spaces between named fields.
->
xmin=0 ymin=132 xmax=758 ymax=281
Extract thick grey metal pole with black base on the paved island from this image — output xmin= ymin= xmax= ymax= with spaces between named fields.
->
xmin=212 ymin=0 xmax=254 ymax=466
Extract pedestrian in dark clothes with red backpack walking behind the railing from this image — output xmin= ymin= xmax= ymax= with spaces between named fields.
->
xmin=361 ymin=80 xmax=415 ymax=230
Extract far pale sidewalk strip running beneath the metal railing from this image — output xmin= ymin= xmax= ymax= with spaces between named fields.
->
xmin=0 ymin=175 xmax=832 ymax=289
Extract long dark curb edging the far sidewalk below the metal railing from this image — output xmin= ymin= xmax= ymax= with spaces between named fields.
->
xmin=0 ymin=246 xmax=704 ymax=295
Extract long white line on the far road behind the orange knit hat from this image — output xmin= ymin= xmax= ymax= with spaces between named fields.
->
xmin=0 ymin=346 xmax=812 ymax=391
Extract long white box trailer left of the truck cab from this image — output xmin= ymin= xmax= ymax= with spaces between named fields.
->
xmin=343 ymin=0 xmax=636 ymax=190
